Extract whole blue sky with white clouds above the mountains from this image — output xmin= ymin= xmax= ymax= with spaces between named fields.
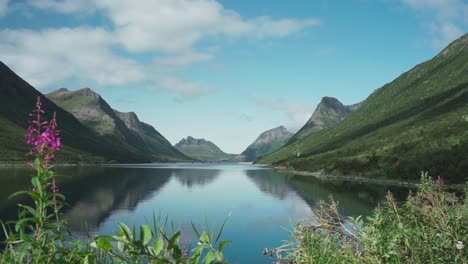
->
xmin=0 ymin=0 xmax=468 ymax=153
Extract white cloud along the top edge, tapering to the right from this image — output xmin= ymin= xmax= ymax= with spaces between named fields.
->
xmin=26 ymin=0 xmax=320 ymax=53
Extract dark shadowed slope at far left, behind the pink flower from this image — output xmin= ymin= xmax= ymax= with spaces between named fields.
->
xmin=0 ymin=62 xmax=151 ymax=163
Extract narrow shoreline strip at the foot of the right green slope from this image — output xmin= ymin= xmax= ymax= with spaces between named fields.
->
xmin=272 ymin=166 xmax=465 ymax=190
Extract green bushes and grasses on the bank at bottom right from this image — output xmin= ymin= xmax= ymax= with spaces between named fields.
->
xmin=264 ymin=174 xmax=468 ymax=263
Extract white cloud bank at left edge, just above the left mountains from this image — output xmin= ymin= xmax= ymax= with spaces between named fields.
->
xmin=0 ymin=27 xmax=144 ymax=89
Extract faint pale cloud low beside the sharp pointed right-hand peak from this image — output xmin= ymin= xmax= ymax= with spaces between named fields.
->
xmin=255 ymin=99 xmax=313 ymax=131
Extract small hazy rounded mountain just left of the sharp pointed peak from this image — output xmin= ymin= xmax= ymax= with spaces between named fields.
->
xmin=241 ymin=126 xmax=293 ymax=161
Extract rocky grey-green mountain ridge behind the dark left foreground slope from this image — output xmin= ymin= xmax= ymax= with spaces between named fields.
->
xmin=46 ymin=88 xmax=187 ymax=161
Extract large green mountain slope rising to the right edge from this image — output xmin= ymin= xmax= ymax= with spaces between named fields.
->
xmin=259 ymin=34 xmax=468 ymax=182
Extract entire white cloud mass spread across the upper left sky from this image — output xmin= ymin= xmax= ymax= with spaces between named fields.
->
xmin=0 ymin=0 xmax=320 ymax=101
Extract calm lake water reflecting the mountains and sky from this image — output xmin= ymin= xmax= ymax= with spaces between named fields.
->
xmin=0 ymin=164 xmax=407 ymax=263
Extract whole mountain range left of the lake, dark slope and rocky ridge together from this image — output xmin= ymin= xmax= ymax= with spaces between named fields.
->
xmin=0 ymin=62 xmax=190 ymax=163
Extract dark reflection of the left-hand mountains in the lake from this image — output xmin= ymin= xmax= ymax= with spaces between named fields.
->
xmin=0 ymin=167 xmax=220 ymax=232
